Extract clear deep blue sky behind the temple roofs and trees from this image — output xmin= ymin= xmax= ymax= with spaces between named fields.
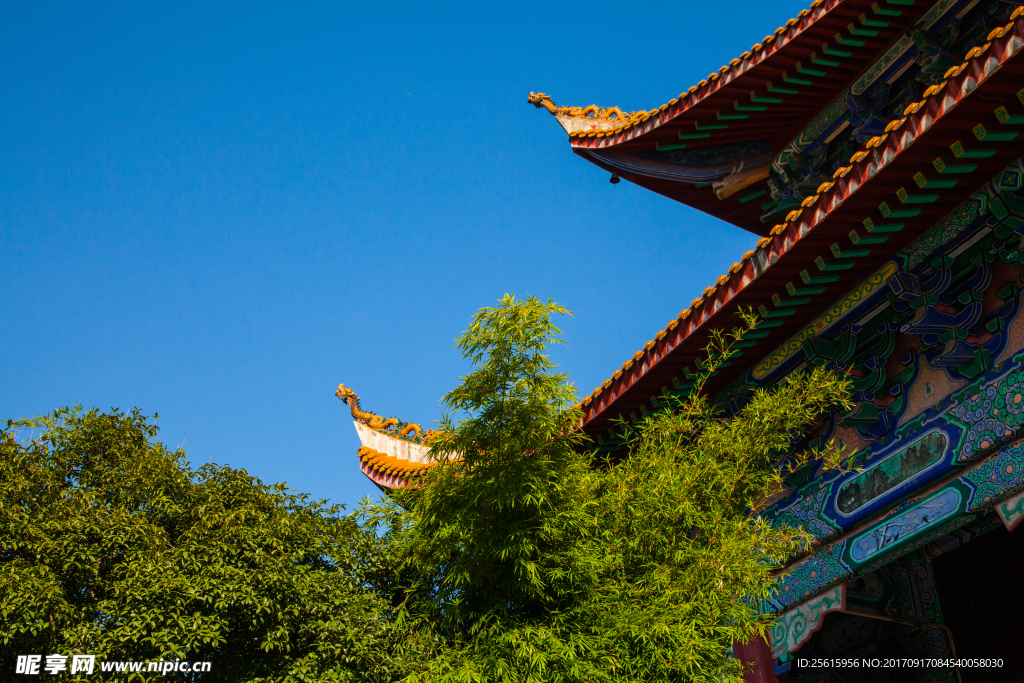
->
xmin=0 ymin=0 xmax=809 ymax=506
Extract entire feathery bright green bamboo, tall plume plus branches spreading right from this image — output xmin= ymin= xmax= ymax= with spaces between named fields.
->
xmin=380 ymin=296 xmax=847 ymax=683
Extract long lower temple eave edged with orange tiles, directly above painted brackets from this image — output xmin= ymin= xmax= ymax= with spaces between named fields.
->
xmin=569 ymin=7 xmax=1024 ymax=444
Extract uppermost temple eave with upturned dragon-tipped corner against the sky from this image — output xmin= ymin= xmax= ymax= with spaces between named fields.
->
xmin=528 ymin=0 xmax=956 ymax=236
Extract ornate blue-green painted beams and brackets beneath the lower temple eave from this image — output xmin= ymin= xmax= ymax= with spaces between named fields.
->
xmin=733 ymin=160 xmax=1024 ymax=613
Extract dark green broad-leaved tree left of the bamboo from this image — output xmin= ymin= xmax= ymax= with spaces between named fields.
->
xmin=0 ymin=409 xmax=430 ymax=681
